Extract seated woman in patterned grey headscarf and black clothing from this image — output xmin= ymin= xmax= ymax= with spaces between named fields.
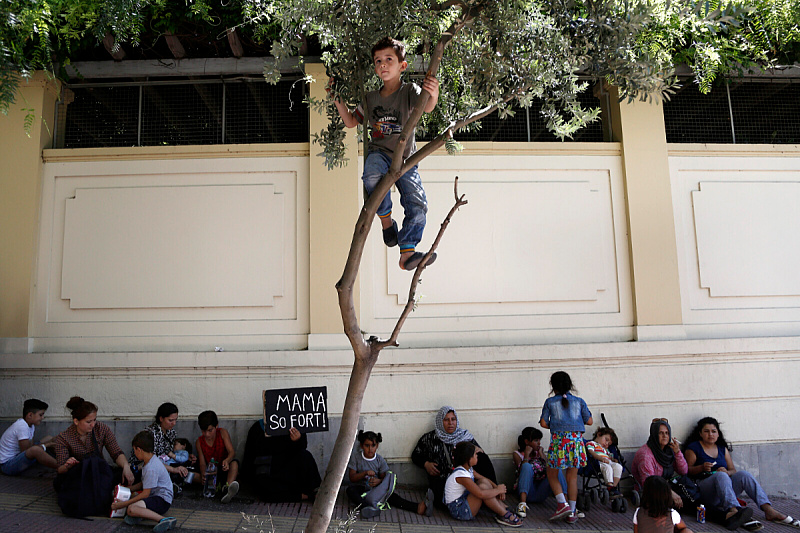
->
xmin=411 ymin=405 xmax=497 ymax=508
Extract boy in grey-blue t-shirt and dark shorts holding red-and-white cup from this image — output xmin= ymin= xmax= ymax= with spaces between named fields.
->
xmin=111 ymin=431 xmax=177 ymax=533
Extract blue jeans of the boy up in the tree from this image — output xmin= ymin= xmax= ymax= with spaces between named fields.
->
xmin=361 ymin=151 xmax=428 ymax=252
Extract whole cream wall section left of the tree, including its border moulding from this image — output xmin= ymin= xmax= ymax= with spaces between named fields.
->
xmin=30 ymin=157 xmax=309 ymax=351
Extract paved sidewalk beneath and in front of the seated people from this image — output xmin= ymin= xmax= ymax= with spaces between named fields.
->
xmin=0 ymin=468 xmax=800 ymax=533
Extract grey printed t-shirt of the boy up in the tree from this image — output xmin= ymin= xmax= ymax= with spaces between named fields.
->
xmin=356 ymin=83 xmax=422 ymax=157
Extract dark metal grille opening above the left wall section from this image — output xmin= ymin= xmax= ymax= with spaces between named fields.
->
xmin=56 ymin=79 xmax=308 ymax=148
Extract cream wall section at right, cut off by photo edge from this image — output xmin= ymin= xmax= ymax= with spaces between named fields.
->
xmin=670 ymin=145 xmax=800 ymax=337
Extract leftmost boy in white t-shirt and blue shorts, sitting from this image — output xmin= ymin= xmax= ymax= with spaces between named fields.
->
xmin=0 ymin=398 xmax=58 ymax=476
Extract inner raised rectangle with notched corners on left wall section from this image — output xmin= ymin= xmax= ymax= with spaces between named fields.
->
xmin=61 ymin=185 xmax=285 ymax=309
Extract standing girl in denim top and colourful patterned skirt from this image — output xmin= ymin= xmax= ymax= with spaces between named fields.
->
xmin=539 ymin=371 xmax=593 ymax=524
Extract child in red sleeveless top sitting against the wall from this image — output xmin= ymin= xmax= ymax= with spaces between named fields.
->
xmin=195 ymin=411 xmax=239 ymax=503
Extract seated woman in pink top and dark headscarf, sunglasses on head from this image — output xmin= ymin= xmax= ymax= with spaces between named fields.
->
xmin=632 ymin=418 xmax=689 ymax=509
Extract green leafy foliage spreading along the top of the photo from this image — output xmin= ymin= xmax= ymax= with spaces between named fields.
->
xmin=0 ymin=0 xmax=800 ymax=139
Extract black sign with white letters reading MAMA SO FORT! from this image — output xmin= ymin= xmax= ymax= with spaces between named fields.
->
xmin=262 ymin=387 xmax=328 ymax=437
